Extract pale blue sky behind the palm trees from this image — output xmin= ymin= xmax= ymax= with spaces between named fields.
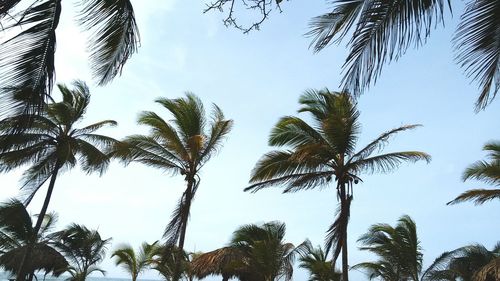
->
xmin=0 ymin=0 xmax=500 ymax=281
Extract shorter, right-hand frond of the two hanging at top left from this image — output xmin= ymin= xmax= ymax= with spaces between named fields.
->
xmin=79 ymin=0 xmax=139 ymax=85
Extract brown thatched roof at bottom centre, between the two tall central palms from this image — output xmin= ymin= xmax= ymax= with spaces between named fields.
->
xmin=191 ymin=247 xmax=244 ymax=279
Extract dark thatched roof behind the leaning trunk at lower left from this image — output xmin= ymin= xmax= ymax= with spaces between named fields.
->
xmin=0 ymin=243 xmax=68 ymax=276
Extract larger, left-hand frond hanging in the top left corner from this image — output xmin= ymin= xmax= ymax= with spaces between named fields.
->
xmin=0 ymin=0 xmax=61 ymax=121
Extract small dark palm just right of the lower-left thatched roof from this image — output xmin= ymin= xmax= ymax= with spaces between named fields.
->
xmin=51 ymin=224 xmax=111 ymax=281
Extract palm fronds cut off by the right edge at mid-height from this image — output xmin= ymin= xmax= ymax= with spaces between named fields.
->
xmin=448 ymin=142 xmax=500 ymax=205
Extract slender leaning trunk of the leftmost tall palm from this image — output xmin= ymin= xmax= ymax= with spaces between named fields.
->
xmin=16 ymin=163 xmax=60 ymax=281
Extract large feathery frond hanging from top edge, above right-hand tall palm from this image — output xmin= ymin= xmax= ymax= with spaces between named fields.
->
xmin=326 ymin=0 xmax=450 ymax=96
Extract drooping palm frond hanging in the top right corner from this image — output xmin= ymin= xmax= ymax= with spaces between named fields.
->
xmin=453 ymin=0 xmax=500 ymax=111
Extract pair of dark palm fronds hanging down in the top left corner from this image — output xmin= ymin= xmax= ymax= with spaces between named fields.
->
xmin=0 ymin=0 xmax=139 ymax=129
